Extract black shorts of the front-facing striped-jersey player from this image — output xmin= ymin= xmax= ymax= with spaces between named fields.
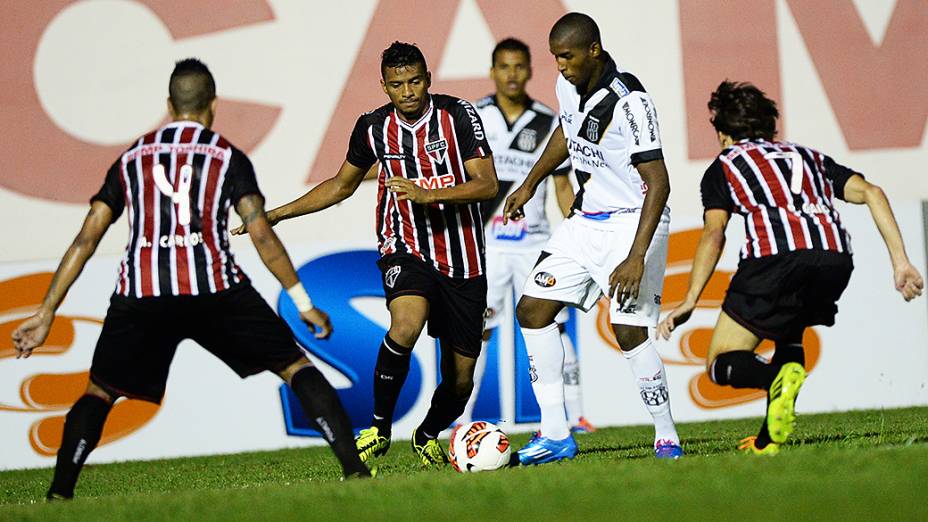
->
xmin=377 ymin=254 xmax=487 ymax=359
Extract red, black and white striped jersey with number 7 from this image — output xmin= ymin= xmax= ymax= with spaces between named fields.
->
xmin=702 ymin=140 xmax=857 ymax=259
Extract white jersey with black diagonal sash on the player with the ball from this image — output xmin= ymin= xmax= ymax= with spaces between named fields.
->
xmin=556 ymin=55 xmax=669 ymax=223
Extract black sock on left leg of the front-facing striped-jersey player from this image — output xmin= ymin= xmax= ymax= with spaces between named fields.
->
xmin=371 ymin=335 xmax=412 ymax=437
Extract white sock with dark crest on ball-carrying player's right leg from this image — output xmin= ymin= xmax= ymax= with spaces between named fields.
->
xmin=622 ymin=339 xmax=680 ymax=444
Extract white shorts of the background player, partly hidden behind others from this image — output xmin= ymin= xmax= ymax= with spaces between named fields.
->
xmin=484 ymin=247 xmax=568 ymax=330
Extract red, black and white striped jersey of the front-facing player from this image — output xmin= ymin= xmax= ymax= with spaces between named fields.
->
xmin=347 ymin=94 xmax=490 ymax=279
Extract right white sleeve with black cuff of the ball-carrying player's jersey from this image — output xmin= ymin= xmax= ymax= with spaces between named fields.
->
xmin=615 ymin=91 xmax=664 ymax=165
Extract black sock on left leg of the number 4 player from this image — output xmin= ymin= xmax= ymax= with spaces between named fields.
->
xmin=48 ymin=394 xmax=113 ymax=498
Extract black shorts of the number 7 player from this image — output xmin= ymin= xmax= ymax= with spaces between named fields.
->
xmin=722 ymin=250 xmax=854 ymax=342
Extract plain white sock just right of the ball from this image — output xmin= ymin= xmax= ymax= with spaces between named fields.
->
xmin=522 ymin=323 xmax=570 ymax=440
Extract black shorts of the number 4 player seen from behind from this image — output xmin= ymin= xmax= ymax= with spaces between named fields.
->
xmin=90 ymin=283 xmax=304 ymax=403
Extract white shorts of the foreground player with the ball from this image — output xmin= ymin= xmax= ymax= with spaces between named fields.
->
xmin=523 ymin=214 xmax=670 ymax=327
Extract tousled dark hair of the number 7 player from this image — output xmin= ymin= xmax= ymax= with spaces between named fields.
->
xmin=709 ymin=80 xmax=780 ymax=140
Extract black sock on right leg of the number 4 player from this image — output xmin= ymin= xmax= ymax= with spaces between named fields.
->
xmin=290 ymin=366 xmax=370 ymax=475
